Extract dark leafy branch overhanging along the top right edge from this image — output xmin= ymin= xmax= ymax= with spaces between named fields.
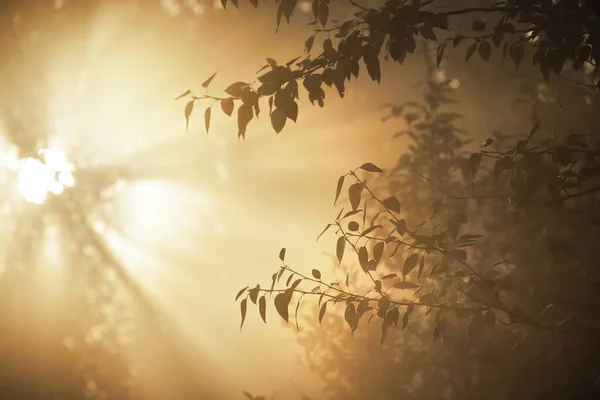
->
xmin=178 ymin=0 xmax=600 ymax=138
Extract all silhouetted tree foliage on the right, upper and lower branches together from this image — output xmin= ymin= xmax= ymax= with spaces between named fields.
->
xmin=182 ymin=0 xmax=600 ymax=398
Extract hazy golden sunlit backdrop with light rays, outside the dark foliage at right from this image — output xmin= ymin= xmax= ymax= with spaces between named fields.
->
xmin=0 ymin=0 xmax=592 ymax=400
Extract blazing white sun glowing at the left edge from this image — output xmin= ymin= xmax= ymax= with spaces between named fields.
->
xmin=17 ymin=149 xmax=75 ymax=204
